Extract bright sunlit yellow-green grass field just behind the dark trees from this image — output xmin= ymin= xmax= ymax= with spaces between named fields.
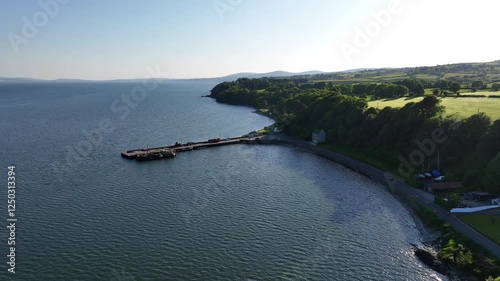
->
xmin=368 ymin=95 xmax=500 ymax=120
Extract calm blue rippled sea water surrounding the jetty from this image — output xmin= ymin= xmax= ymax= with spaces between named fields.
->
xmin=0 ymin=82 xmax=446 ymax=281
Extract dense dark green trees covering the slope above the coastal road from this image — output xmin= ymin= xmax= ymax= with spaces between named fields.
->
xmin=211 ymin=78 xmax=500 ymax=194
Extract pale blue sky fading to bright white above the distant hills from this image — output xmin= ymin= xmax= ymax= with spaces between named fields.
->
xmin=0 ymin=0 xmax=500 ymax=80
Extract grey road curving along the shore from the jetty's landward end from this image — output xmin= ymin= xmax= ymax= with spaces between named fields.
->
xmin=262 ymin=134 xmax=500 ymax=258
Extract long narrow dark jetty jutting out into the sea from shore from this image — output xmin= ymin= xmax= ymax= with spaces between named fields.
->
xmin=121 ymin=135 xmax=263 ymax=161
